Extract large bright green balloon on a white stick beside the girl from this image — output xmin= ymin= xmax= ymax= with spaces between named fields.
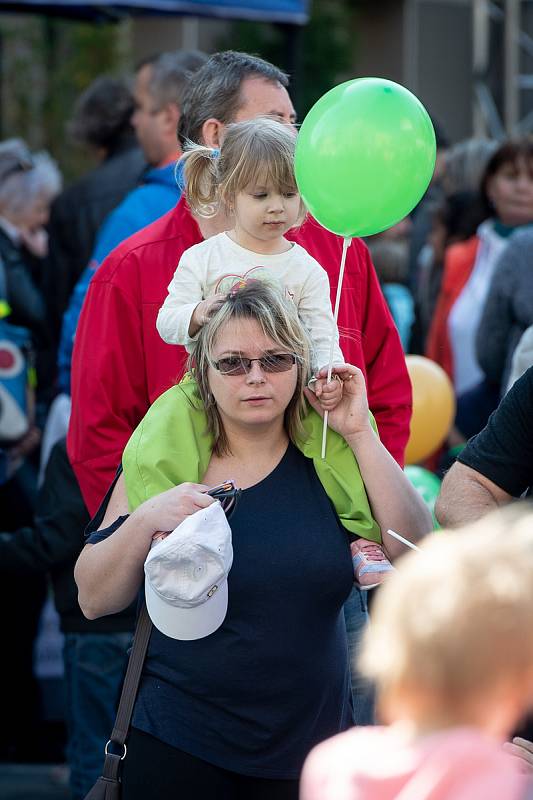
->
xmin=295 ymin=78 xmax=436 ymax=238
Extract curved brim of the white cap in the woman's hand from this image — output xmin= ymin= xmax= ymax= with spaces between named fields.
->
xmin=144 ymin=580 xmax=228 ymax=641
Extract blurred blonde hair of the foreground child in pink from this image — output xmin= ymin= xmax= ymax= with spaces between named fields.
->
xmin=359 ymin=509 xmax=533 ymax=716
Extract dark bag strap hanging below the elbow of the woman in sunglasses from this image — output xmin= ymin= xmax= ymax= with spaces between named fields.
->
xmin=102 ymin=603 xmax=152 ymax=780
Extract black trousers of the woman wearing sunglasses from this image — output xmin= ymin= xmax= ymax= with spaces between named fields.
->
xmin=122 ymin=728 xmax=298 ymax=800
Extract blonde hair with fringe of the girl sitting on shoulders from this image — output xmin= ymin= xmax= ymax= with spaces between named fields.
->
xmin=181 ymin=117 xmax=306 ymax=223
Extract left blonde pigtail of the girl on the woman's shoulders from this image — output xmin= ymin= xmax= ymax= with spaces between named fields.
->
xmin=180 ymin=144 xmax=218 ymax=217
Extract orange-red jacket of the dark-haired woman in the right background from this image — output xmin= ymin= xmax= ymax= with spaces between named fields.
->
xmin=426 ymin=236 xmax=479 ymax=383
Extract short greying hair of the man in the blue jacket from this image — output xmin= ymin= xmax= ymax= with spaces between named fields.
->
xmin=148 ymin=50 xmax=207 ymax=110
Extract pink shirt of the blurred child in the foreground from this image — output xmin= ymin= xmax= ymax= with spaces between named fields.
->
xmin=300 ymin=725 xmax=528 ymax=800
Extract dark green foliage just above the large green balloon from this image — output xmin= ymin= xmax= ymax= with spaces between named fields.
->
xmin=218 ymin=0 xmax=356 ymax=118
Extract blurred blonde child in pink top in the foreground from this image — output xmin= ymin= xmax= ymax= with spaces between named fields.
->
xmin=300 ymin=509 xmax=533 ymax=800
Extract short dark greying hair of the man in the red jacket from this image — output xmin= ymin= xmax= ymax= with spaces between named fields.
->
xmin=178 ymin=50 xmax=289 ymax=145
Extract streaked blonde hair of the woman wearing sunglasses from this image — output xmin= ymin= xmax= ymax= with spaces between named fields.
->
xmin=188 ymin=281 xmax=311 ymax=455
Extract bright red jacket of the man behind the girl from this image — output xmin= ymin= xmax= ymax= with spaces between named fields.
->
xmin=68 ymin=199 xmax=411 ymax=514
